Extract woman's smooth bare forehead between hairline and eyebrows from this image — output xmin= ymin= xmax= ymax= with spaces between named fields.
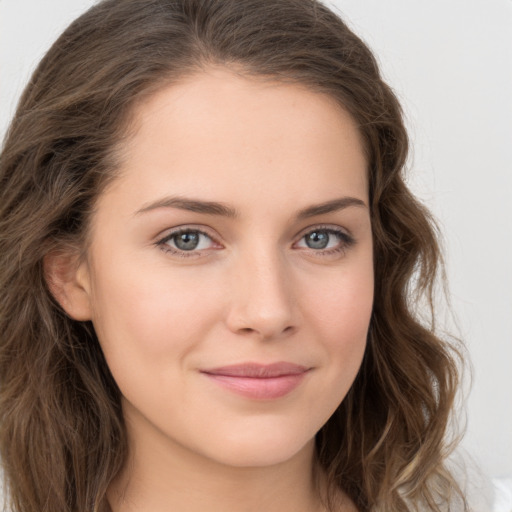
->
xmin=104 ymin=68 xmax=368 ymax=214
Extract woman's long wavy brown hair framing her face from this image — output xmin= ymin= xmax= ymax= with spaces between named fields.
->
xmin=0 ymin=0 xmax=463 ymax=512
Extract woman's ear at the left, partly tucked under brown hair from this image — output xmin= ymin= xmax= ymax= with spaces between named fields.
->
xmin=43 ymin=251 xmax=92 ymax=321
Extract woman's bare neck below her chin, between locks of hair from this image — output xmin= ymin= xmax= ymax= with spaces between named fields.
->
xmin=108 ymin=410 xmax=324 ymax=512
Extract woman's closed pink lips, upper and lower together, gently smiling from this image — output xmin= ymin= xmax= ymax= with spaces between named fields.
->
xmin=201 ymin=362 xmax=311 ymax=400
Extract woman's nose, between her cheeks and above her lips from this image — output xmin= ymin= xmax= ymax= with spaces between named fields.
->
xmin=227 ymin=248 xmax=298 ymax=340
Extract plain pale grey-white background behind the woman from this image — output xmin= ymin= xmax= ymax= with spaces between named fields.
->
xmin=0 ymin=0 xmax=512 ymax=488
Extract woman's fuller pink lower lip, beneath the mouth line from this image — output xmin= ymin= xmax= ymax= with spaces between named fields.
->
xmin=203 ymin=372 xmax=306 ymax=400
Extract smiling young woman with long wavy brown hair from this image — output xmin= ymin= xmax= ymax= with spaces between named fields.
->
xmin=0 ymin=0 xmax=464 ymax=512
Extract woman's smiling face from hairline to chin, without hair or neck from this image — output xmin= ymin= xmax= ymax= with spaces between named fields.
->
xmin=81 ymin=69 xmax=373 ymax=467
